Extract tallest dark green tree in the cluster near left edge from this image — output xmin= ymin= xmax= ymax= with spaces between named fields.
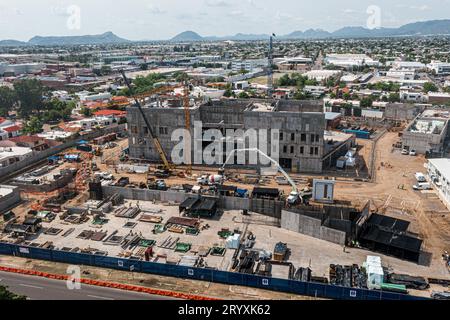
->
xmin=14 ymin=79 xmax=44 ymax=119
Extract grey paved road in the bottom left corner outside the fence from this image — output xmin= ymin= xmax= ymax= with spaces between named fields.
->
xmin=0 ymin=272 xmax=178 ymax=300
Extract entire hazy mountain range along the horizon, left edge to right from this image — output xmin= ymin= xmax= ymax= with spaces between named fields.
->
xmin=0 ymin=19 xmax=450 ymax=47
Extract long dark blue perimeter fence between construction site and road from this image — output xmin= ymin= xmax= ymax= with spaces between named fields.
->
xmin=0 ymin=243 xmax=427 ymax=300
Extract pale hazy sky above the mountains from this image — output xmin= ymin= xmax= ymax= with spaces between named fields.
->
xmin=0 ymin=0 xmax=450 ymax=40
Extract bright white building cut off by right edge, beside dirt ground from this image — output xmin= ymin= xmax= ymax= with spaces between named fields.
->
xmin=428 ymin=159 xmax=450 ymax=210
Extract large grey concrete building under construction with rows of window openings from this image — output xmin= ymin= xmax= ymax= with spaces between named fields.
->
xmin=127 ymin=100 xmax=326 ymax=173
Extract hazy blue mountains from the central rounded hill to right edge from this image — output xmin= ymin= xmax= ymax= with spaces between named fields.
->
xmin=171 ymin=20 xmax=450 ymax=42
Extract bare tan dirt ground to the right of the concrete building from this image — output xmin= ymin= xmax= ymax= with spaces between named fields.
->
xmin=335 ymin=132 xmax=450 ymax=268
